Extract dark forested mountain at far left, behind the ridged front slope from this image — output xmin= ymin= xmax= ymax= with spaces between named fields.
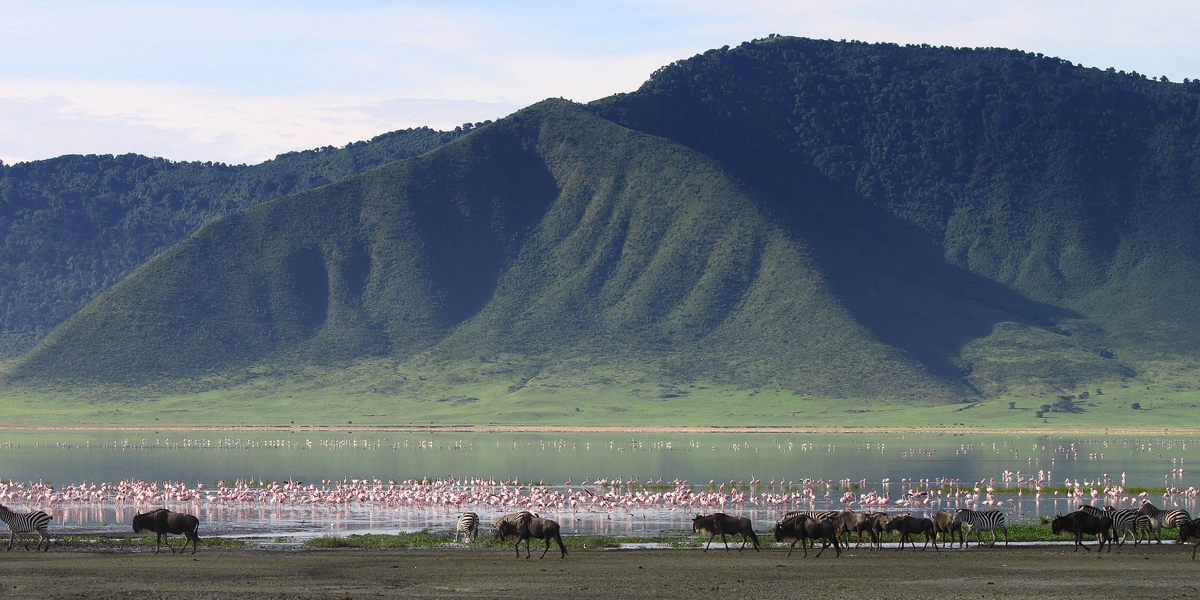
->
xmin=0 ymin=124 xmax=463 ymax=359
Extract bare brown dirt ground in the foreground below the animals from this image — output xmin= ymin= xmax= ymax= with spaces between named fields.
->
xmin=0 ymin=544 xmax=1200 ymax=600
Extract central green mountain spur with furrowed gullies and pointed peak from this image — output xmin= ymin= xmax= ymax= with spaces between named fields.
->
xmin=7 ymin=101 xmax=959 ymax=397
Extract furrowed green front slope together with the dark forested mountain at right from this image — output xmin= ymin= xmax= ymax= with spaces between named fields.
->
xmin=8 ymin=37 xmax=1200 ymax=402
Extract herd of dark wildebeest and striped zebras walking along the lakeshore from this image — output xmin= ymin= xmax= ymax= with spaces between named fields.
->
xmin=0 ymin=502 xmax=1200 ymax=560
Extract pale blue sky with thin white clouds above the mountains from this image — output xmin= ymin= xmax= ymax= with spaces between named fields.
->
xmin=0 ymin=0 xmax=1200 ymax=164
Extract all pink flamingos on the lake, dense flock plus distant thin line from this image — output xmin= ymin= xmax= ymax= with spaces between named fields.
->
xmin=0 ymin=439 xmax=1200 ymax=535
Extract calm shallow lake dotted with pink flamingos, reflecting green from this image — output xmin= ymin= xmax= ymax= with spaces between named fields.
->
xmin=0 ymin=431 xmax=1200 ymax=539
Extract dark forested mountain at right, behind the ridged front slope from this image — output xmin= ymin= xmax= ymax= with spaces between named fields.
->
xmin=593 ymin=37 xmax=1200 ymax=392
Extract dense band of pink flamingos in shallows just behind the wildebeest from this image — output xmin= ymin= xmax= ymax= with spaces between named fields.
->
xmin=0 ymin=470 xmax=1200 ymax=523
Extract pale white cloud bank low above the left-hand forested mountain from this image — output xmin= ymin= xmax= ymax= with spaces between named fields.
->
xmin=0 ymin=80 xmax=520 ymax=163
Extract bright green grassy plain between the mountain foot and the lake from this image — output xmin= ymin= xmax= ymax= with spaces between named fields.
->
xmin=0 ymin=350 xmax=1200 ymax=433
